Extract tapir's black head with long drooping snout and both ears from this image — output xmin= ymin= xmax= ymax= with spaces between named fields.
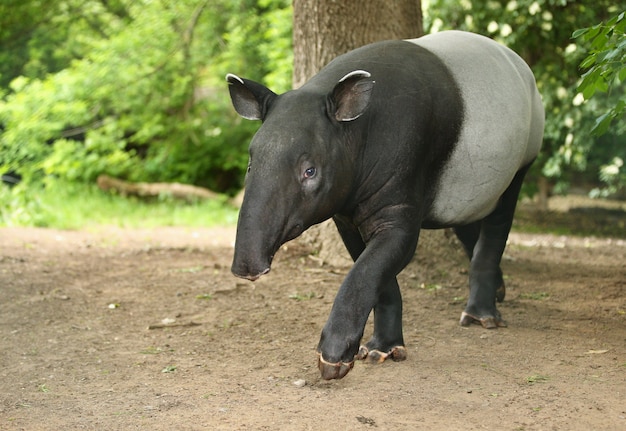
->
xmin=226 ymin=70 xmax=374 ymax=280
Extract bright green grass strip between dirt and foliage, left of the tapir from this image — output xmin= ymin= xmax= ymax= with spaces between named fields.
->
xmin=0 ymin=182 xmax=237 ymax=229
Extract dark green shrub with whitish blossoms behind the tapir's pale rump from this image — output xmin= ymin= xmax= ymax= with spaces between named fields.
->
xmin=425 ymin=0 xmax=626 ymax=191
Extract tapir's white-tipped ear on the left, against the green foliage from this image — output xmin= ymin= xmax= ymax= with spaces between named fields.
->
xmin=226 ymin=73 xmax=276 ymax=120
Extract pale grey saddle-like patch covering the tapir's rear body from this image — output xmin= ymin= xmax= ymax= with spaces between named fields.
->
xmin=412 ymin=32 xmax=543 ymax=226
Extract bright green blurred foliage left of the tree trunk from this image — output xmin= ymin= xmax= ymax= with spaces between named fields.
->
xmin=0 ymin=0 xmax=291 ymax=191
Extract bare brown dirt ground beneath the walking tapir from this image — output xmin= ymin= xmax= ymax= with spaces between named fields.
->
xmin=0 ymin=201 xmax=626 ymax=430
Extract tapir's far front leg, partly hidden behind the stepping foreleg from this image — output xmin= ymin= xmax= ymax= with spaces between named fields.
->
xmin=334 ymin=217 xmax=406 ymax=363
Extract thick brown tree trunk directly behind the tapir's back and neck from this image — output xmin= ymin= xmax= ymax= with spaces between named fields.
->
xmin=293 ymin=0 xmax=424 ymax=265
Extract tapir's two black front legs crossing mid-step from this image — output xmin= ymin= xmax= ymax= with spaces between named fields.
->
xmin=317 ymin=219 xmax=419 ymax=379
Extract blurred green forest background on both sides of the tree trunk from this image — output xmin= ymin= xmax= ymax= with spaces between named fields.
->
xmin=0 ymin=0 xmax=626 ymax=227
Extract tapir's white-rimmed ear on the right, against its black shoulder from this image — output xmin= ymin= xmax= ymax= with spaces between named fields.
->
xmin=331 ymin=70 xmax=375 ymax=121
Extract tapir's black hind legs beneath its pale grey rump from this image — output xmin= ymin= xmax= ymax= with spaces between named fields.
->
xmin=455 ymin=165 xmax=530 ymax=329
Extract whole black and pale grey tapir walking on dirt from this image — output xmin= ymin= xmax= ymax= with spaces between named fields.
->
xmin=227 ymin=31 xmax=544 ymax=379
